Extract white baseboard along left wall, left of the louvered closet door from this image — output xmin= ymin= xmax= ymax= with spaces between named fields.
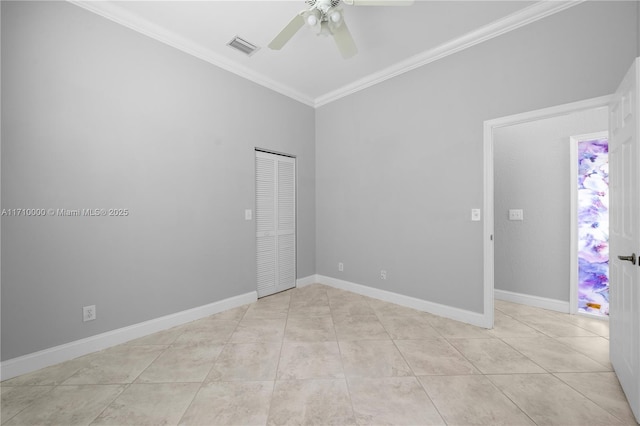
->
xmin=0 ymin=291 xmax=258 ymax=380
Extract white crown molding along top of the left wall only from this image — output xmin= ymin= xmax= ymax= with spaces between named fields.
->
xmin=67 ymin=0 xmax=315 ymax=107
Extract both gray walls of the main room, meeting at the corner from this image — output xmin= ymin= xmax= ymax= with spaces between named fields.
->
xmin=1 ymin=2 xmax=638 ymax=360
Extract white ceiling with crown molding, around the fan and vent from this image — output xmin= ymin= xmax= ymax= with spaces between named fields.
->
xmin=70 ymin=0 xmax=580 ymax=106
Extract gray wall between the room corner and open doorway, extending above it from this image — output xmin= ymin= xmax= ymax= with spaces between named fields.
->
xmin=316 ymin=2 xmax=638 ymax=312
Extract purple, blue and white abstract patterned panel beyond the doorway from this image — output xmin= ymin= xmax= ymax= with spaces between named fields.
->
xmin=578 ymin=139 xmax=609 ymax=316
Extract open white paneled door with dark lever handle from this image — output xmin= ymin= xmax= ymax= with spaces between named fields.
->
xmin=609 ymin=59 xmax=640 ymax=420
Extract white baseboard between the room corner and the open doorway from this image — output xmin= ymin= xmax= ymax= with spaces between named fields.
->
xmin=316 ymin=275 xmax=492 ymax=328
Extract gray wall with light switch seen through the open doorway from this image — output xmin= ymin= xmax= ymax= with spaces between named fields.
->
xmin=494 ymin=108 xmax=609 ymax=302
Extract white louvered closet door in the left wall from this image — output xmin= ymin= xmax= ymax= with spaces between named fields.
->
xmin=256 ymin=151 xmax=296 ymax=297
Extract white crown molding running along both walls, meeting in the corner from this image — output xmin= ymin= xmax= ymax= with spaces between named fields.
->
xmin=67 ymin=0 xmax=585 ymax=107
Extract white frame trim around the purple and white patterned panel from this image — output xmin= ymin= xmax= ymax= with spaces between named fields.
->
xmin=569 ymin=131 xmax=609 ymax=316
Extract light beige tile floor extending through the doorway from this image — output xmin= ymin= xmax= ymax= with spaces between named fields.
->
xmin=0 ymin=284 xmax=636 ymax=425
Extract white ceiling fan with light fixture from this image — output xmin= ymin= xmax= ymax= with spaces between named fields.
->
xmin=269 ymin=0 xmax=413 ymax=59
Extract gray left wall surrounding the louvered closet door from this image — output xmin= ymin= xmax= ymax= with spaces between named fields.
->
xmin=2 ymin=1 xmax=315 ymax=360
